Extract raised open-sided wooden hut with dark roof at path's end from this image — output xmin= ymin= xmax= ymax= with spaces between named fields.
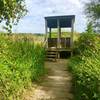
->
xmin=45 ymin=15 xmax=75 ymax=58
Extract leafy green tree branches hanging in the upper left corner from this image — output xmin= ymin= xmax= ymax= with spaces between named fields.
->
xmin=0 ymin=0 xmax=27 ymax=32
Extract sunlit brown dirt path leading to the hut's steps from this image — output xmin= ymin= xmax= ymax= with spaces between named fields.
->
xmin=25 ymin=60 xmax=73 ymax=100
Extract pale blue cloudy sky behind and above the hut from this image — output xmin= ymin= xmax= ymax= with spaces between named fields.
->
xmin=1 ymin=0 xmax=86 ymax=33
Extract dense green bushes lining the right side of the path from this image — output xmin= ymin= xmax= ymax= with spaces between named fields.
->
xmin=69 ymin=31 xmax=100 ymax=100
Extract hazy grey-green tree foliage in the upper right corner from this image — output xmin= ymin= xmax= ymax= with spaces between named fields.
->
xmin=85 ymin=0 xmax=100 ymax=31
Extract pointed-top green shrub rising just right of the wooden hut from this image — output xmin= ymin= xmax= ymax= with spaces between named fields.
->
xmin=74 ymin=22 xmax=97 ymax=54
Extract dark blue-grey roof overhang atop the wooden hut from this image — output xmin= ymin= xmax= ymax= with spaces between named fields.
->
xmin=45 ymin=15 xmax=75 ymax=28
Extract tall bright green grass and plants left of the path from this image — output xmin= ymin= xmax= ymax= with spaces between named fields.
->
xmin=0 ymin=35 xmax=45 ymax=100
